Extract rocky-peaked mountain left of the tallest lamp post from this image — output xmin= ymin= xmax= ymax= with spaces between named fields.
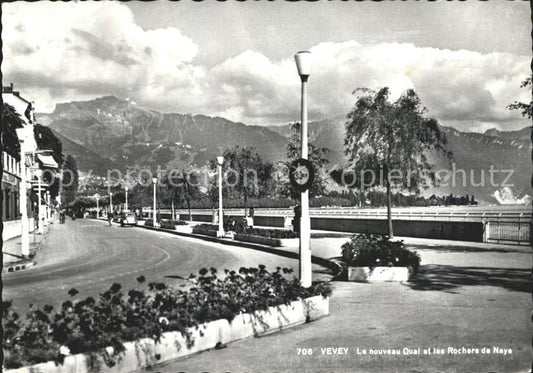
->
xmin=39 ymin=96 xmax=285 ymax=171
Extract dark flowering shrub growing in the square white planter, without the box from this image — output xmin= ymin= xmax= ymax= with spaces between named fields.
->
xmin=341 ymin=234 xmax=420 ymax=273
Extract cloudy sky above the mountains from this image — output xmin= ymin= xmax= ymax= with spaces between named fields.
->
xmin=2 ymin=0 xmax=532 ymax=132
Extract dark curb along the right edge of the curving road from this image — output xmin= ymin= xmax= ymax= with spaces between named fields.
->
xmin=135 ymin=225 xmax=342 ymax=278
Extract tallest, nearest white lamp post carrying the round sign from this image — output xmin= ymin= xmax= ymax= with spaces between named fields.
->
xmin=294 ymin=51 xmax=312 ymax=287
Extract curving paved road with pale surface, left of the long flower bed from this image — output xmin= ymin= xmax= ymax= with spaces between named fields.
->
xmin=3 ymin=219 xmax=327 ymax=311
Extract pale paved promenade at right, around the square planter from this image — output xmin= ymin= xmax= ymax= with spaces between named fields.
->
xmin=142 ymin=238 xmax=533 ymax=373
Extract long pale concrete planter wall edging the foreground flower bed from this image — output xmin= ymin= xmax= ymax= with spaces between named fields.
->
xmin=7 ymin=295 xmax=329 ymax=373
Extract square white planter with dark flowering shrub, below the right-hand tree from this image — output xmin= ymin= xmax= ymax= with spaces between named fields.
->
xmin=342 ymin=234 xmax=420 ymax=281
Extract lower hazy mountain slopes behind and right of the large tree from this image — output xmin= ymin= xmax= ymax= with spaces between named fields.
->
xmin=268 ymin=118 xmax=533 ymax=203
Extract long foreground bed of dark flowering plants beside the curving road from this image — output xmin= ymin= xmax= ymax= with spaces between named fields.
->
xmin=3 ymin=266 xmax=331 ymax=369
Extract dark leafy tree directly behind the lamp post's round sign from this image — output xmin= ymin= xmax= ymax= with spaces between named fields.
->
xmin=280 ymin=122 xmax=329 ymax=199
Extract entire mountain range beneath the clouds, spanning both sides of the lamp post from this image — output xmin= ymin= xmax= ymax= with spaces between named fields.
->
xmin=37 ymin=96 xmax=532 ymax=203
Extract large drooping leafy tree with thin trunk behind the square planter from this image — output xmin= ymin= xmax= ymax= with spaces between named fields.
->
xmin=344 ymin=87 xmax=451 ymax=237
